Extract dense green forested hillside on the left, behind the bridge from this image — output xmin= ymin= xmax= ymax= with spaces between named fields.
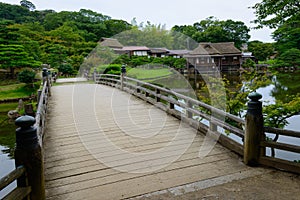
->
xmin=0 ymin=1 xmax=131 ymax=72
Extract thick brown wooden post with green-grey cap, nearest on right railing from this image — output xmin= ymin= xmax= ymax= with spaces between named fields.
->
xmin=244 ymin=92 xmax=264 ymax=166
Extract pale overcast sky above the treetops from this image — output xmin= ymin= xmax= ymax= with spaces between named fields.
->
xmin=0 ymin=0 xmax=273 ymax=42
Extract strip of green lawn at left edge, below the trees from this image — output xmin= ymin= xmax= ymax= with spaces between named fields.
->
xmin=0 ymin=83 xmax=37 ymax=100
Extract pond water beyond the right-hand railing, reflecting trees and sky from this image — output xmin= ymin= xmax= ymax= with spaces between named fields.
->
xmin=189 ymin=71 xmax=300 ymax=161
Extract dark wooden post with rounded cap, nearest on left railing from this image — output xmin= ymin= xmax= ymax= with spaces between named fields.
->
xmin=15 ymin=115 xmax=45 ymax=200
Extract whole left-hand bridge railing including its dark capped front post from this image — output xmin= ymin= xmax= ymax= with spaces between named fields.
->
xmin=0 ymin=77 xmax=51 ymax=200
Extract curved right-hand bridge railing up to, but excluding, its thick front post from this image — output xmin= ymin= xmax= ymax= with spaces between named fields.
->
xmin=95 ymin=74 xmax=245 ymax=155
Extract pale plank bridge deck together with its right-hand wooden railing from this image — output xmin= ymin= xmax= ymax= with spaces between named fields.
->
xmin=0 ymin=75 xmax=300 ymax=199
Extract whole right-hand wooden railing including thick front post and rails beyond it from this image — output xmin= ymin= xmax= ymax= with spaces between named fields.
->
xmin=94 ymin=74 xmax=300 ymax=173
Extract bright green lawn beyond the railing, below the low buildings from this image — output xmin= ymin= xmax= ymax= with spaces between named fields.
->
xmin=127 ymin=68 xmax=173 ymax=80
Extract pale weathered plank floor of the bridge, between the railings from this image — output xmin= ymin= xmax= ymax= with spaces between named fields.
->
xmin=44 ymin=84 xmax=264 ymax=200
